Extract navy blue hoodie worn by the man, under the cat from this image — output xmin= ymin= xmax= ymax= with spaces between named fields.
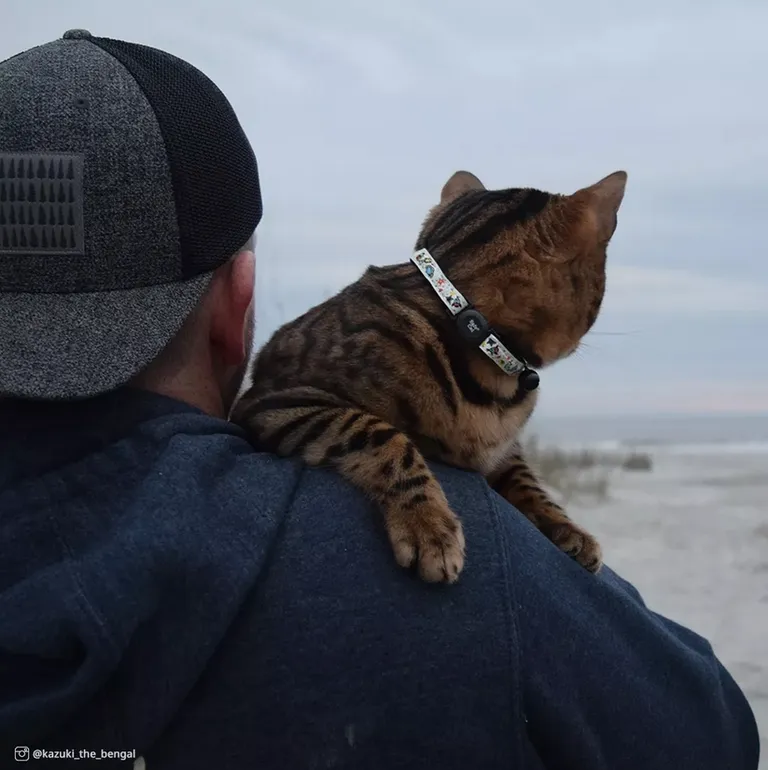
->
xmin=0 ymin=390 xmax=758 ymax=770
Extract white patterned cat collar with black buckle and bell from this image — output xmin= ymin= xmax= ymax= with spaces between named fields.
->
xmin=411 ymin=249 xmax=539 ymax=390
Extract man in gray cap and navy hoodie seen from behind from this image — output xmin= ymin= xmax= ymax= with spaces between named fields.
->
xmin=0 ymin=30 xmax=758 ymax=770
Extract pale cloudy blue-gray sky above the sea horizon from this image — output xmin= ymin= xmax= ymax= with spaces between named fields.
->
xmin=6 ymin=0 xmax=768 ymax=417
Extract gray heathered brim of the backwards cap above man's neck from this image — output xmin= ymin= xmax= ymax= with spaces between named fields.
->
xmin=0 ymin=273 xmax=213 ymax=399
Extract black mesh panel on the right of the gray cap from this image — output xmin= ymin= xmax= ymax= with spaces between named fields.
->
xmin=91 ymin=37 xmax=262 ymax=277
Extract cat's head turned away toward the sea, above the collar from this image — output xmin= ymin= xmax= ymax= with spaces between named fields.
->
xmin=416 ymin=171 xmax=627 ymax=367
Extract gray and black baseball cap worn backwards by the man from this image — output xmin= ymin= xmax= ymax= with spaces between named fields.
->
xmin=0 ymin=30 xmax=262 ymax=399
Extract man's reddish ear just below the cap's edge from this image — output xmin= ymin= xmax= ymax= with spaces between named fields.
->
xmin=210 ymin=249 xmax=255 ymax=366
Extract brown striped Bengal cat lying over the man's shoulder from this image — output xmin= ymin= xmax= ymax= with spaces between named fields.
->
xmin=232 ymin=171 xmax=627 ymax=583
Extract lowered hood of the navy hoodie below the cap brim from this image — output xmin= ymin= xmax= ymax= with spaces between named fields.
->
xmin=0 ymin=390 xmax=300 ymax=766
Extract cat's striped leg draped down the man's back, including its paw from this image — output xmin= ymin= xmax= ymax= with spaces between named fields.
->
xmin=232 ymin=388 xmax=464 ymax=583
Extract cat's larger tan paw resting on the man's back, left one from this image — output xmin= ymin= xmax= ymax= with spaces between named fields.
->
xmin=387 ymin=502 xmax=464 ymax=583
